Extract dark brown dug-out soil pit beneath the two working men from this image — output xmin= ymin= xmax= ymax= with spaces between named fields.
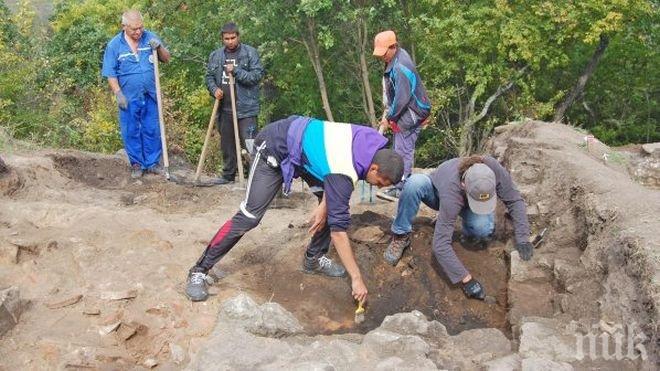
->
xmin=220 ymin=211 xmax=510 ymax=335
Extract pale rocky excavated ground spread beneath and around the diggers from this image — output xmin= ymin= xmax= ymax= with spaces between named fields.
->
xmin=0 ymin=122 xmax=660 ymax=370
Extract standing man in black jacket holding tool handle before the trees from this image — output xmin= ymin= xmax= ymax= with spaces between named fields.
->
xmin=206 ymin=22 xmax=264 ymax=183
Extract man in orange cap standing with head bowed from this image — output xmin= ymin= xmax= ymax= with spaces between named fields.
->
xmin=373 ymin=30 xmax=431 ymax=201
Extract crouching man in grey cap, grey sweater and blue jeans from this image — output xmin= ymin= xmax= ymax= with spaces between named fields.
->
xmin=384 ymin=156 xmax=534 ymax=299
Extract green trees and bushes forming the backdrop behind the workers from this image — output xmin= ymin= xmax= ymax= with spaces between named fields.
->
xmin=0 ymin=0 xmax=660 ymax=166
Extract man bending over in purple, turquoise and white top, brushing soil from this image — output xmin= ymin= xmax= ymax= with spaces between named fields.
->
xmin=186 ymin=116 xmax=403 ymax=302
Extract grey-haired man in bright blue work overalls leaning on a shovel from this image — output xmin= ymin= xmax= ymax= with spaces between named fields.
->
xmin=102 ymin=10 xmax=170 ymax=178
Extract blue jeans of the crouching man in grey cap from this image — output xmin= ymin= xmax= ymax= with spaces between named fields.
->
xmin=392 ymin=174 xmax=495 ymax=239
